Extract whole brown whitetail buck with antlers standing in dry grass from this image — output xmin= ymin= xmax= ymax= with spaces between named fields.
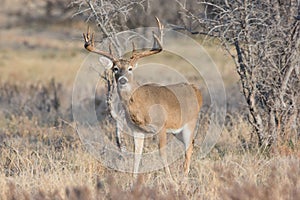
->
xmin=83 ymin=18 xmax=202 ymax=174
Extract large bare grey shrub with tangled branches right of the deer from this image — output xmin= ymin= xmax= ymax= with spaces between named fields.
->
xmin=182 ymin=0 xmax=300 ymax=147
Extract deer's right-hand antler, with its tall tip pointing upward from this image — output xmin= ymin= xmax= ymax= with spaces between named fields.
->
xmin=130 ymin=17 xmax=163 ymax=61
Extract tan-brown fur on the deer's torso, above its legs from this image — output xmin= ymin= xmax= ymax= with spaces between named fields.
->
xmin=120 ymin=83 xmax=202 ymax=132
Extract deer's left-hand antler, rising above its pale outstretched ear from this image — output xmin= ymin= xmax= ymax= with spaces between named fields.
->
xmin=82 ymin=26 xmax=118 ymax=62
